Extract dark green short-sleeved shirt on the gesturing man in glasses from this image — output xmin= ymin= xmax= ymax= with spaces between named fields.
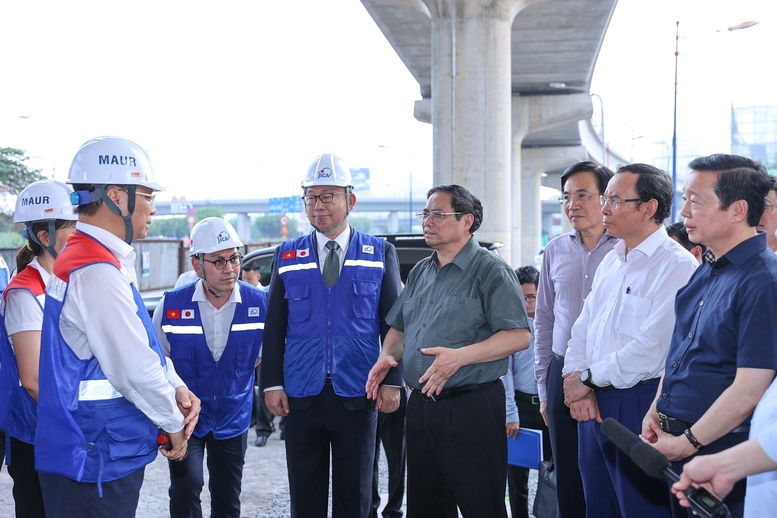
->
xmin=386 ymin=236 xmax=529 ymax=389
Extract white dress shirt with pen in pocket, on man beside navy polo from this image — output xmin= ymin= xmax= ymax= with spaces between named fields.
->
xmin=563 ymin=226 xmax=698 ymax=389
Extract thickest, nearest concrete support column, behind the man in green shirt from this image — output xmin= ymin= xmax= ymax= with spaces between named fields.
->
xmin=424 ymin=0 xmax=527 ymax=261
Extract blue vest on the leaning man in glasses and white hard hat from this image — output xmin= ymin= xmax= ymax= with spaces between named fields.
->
xmin=162 ymin=281 xmax=267 ymax=440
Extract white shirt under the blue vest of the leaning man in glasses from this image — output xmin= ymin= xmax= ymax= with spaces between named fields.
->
xmin=154 ymin=280 xmax=243 ymax=361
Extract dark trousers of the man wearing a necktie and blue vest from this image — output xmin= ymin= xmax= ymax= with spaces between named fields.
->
xmin=284 ymin=384 xmax=378 ymax=518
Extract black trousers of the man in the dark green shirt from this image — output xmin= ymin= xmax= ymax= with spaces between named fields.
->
xmin=407 ymin=380 xmax=507 ymax=518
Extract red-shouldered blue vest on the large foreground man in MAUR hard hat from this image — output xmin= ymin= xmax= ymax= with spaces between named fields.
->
xmin=35 ymin=231 xmax=165 ymax=487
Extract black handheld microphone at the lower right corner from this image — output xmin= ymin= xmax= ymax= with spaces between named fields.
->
xmin=602 ymin=417 xmax=731 ymax=518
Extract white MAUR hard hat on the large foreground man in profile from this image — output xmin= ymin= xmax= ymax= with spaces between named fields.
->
xmin=67 ymin=137 xmax=164 ymax=191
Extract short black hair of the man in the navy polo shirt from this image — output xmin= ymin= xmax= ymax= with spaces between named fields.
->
xmin=688 ymin=153 xmax=771 ymax=227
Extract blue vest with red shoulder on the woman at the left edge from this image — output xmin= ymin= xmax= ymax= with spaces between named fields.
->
xmin=0 ymin=267 xmax=45 ymax=444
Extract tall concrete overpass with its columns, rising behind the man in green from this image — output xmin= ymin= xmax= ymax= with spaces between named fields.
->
xmin=362 ymin=0 xmax=622 ymax=264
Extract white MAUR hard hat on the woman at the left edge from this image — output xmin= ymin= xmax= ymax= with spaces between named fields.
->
xmin=13 ymin=180 xmax=78 ymax=223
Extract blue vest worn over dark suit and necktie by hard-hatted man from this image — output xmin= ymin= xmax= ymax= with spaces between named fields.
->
xmin=278 ymin=232 xmax=386 ymax=398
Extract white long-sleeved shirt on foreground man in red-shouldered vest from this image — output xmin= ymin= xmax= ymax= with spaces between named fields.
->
xmin=59 ymin=221 xmax=184 ymax=433
